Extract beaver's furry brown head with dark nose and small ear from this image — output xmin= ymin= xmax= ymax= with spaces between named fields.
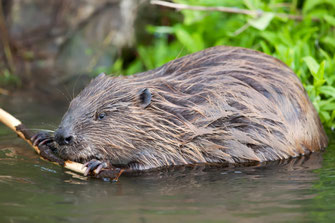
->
xmin=55 ymin=74 xmax=156 ymax=167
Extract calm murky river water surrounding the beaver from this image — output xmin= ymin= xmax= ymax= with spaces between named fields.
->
xmin=0 ymin=93 xmax=335 ymax=223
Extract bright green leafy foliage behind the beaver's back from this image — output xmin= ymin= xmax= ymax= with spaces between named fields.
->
xmin=112 ymin=0 xmax=335 ymax=128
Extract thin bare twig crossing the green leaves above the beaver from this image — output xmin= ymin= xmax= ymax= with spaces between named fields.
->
xmin=150 ymin=0 xmax=320 ymax=21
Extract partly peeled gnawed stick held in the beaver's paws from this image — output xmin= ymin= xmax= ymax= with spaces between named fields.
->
xmin=0 ymin=108 xmax=124 ymax=181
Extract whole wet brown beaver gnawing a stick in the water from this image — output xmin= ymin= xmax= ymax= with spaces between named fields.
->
xmin=34 ymin=46 xmax=328 ymax=174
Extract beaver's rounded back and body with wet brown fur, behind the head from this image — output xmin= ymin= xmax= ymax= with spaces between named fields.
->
xmin=132 ymin=46 xmax=327 ymax=163
